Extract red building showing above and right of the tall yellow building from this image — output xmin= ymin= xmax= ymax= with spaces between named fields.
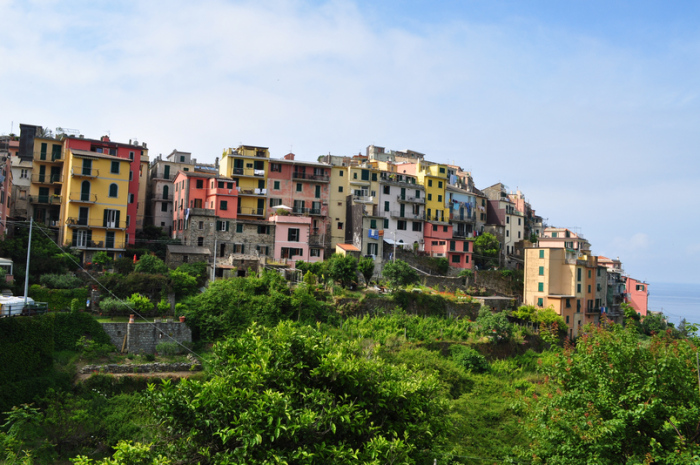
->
xmin=65 ymin=136 xmax=148 ymax=245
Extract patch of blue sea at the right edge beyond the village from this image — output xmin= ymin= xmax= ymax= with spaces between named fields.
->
xmin=649 ymin=282 xmax=700 ymax=326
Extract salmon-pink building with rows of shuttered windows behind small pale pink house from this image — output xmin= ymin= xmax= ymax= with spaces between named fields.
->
xmin=268 ymin=153 xmax=331 ymax=247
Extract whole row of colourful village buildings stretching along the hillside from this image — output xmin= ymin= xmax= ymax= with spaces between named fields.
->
xmin=0 ymin=124 xmax=648 ymax=337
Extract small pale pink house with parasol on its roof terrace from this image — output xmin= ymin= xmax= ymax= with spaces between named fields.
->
xmin=270 ymin=215 xmax=323 ymax=264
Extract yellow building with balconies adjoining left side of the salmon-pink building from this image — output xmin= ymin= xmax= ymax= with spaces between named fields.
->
xmin=219 ymin=145 xmax=270 ymax=219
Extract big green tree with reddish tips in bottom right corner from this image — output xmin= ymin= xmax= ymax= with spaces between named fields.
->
xmin=523 ymin=324 xmax=700 ymax=465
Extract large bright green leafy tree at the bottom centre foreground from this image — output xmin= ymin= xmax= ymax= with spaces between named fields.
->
xmin=148 ymin=322 xmax=447 ymax=464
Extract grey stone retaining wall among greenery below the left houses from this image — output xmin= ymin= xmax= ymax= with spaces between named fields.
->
xmin=102 ymin=322 xmax=192 ymax=354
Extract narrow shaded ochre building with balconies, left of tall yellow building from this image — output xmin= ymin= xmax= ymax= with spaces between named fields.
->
xmin=27 ymin=137 xmax=64 ymax=228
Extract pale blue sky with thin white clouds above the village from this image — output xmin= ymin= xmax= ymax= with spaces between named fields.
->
xmin=0 ymin=0 xmax=700 ymax=286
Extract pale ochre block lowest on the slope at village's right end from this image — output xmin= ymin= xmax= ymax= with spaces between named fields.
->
xmin=523 ymin=248 xmax=589 ymax=338
